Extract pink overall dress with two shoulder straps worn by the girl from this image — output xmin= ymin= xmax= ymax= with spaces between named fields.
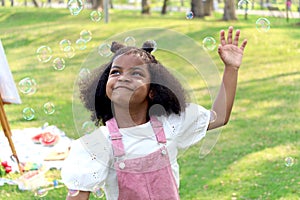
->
xmin=106 ymin=116 xmax=179 ymax=200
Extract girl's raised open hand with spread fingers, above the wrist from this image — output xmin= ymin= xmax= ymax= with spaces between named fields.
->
xmin=218 ymin=26 xmax=247 ymax=69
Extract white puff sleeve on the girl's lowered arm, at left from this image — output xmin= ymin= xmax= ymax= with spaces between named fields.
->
xmin=61 ymin=128 xmax=112 ymax=191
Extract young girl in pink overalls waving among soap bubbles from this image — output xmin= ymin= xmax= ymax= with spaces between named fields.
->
xmin=61 ymin=27 xmax=247 ymax=200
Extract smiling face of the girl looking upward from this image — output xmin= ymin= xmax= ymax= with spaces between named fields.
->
xmin=106 ymin=54 xmax=150 ymax=109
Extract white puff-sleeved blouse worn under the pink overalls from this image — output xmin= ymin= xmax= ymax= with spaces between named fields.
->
xmin=61 ymin=103 xmax=210 ymax=200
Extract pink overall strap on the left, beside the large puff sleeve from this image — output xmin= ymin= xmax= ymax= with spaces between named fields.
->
xmin=105 ymin=118 xmax=125 ymax=157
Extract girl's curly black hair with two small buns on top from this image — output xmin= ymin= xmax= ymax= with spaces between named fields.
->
xmin=79 ymin=41 xmax=187 ymax=126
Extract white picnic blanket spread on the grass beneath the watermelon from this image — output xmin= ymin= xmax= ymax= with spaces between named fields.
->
xmin=0 ymin=125 xmax=72 ymax=171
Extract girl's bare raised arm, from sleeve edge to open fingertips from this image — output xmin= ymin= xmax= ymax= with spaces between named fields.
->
xmin=208 ymin=26 xmax=247 ymax=129
